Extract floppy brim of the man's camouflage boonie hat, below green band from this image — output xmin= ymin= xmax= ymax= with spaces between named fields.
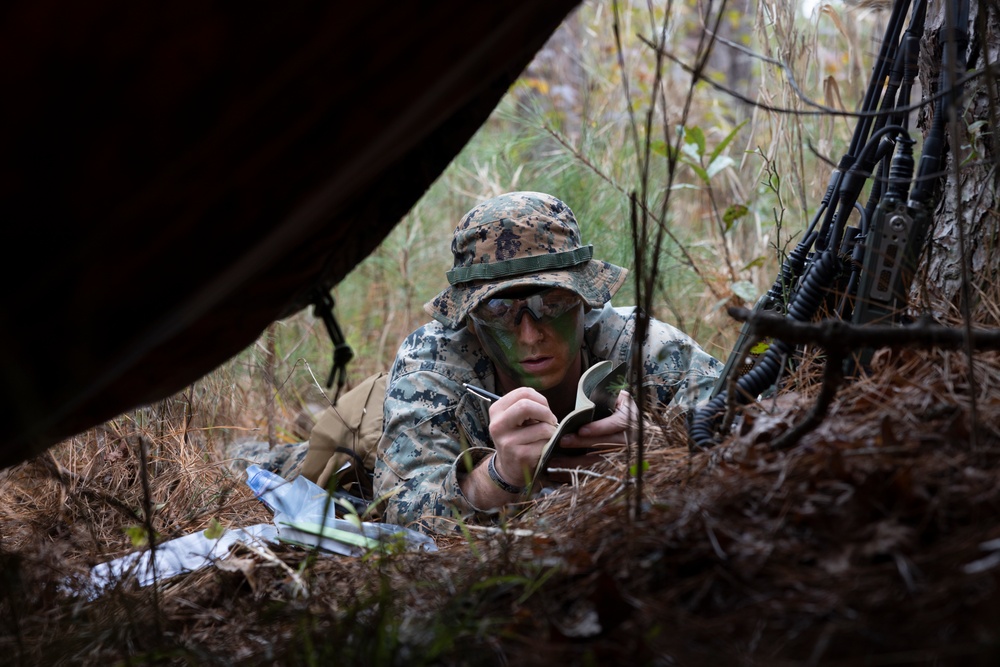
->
xmin=424 ymin=260 xmax=628 ymax=329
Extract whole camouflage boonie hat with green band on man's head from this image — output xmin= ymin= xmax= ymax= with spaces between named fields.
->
xmin=424 ymin=192 xmax=628 ymax=329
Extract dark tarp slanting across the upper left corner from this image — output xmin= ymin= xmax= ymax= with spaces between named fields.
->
xmin=0 ymin=0 xmax=577 ymax=466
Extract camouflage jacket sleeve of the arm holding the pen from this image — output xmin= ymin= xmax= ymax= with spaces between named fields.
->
xmin=374 ymin=322 xmax=496 ymax=529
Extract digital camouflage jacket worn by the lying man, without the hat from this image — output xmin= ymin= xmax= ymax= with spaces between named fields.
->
xmin=374 ymin=305 xmax=721 ymax=529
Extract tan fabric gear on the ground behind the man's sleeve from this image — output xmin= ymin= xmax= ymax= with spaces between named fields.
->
xmin=301 ymin=372 xmax=388 ymax=499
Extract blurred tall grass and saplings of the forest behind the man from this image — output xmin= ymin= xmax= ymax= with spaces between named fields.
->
xmin=213 ymin=0 xmax=885 ymax=454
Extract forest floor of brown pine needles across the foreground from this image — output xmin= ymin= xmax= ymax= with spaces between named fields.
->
xmin=0 ymin=342 xmax=1000 ymax=665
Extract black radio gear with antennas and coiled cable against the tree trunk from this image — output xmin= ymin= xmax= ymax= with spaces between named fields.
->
xmin=688 ymin=0 xmax=969 ymax=451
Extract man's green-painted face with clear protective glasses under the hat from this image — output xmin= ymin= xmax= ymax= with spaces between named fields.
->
xmin=472 ymin=290 xmax=583 ymax=391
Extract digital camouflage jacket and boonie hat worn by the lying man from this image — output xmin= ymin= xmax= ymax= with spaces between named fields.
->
xmin=374 ymin=192 xmax=720 ymax=530
